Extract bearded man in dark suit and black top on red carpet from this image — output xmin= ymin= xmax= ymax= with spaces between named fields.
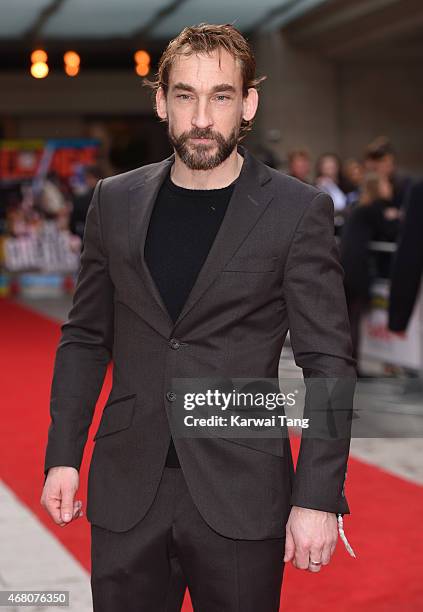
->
xmin=42 ymin=24 xmax=355 ymax=612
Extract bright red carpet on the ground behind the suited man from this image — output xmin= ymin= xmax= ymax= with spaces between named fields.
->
xmin=0 ymin=299 xmax=423 ymax=612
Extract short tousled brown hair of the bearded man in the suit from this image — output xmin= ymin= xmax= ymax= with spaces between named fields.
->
xmin=144 ymin=23 xmax=266 ymax=133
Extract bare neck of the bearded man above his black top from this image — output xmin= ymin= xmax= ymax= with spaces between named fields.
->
xmin=170 ymin=147 xmax=244 ymax=189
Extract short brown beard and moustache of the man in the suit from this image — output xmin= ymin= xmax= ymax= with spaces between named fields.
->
xmin=168 ymin=125 xmax=240 ymax=170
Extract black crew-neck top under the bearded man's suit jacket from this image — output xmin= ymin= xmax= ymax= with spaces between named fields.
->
xmin=145 ymin=174 xmax=236 ymax=467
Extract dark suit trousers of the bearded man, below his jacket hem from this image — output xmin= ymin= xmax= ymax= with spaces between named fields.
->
xmin=91 ymin=467 xmax=285 ymax=612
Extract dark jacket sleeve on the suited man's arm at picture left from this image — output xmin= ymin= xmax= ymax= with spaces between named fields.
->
xmin=44 ymin=180 xmax=114 ymax=475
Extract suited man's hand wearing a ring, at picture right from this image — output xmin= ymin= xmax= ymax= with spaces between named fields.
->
xmin=284 ymin=506 xmax=338 ymax=572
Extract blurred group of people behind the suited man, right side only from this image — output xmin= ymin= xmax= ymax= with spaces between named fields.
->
xmin=287 ymin=136 xmax=423 ymax=368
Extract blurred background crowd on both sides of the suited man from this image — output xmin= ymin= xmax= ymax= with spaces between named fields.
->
xmin=0 ymin=136 xmax=423 ymax=370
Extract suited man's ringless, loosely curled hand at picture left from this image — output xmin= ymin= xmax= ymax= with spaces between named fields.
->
xmin=40 ymin=466 xmax=84 ymax=527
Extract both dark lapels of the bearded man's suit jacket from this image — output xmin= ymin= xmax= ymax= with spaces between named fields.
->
xmin=129 ymin=145 xmax=273 ymax=335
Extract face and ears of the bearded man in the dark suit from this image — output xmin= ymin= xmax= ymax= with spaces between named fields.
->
xmin=156 ymin=49 xmax=257 ymax=170
